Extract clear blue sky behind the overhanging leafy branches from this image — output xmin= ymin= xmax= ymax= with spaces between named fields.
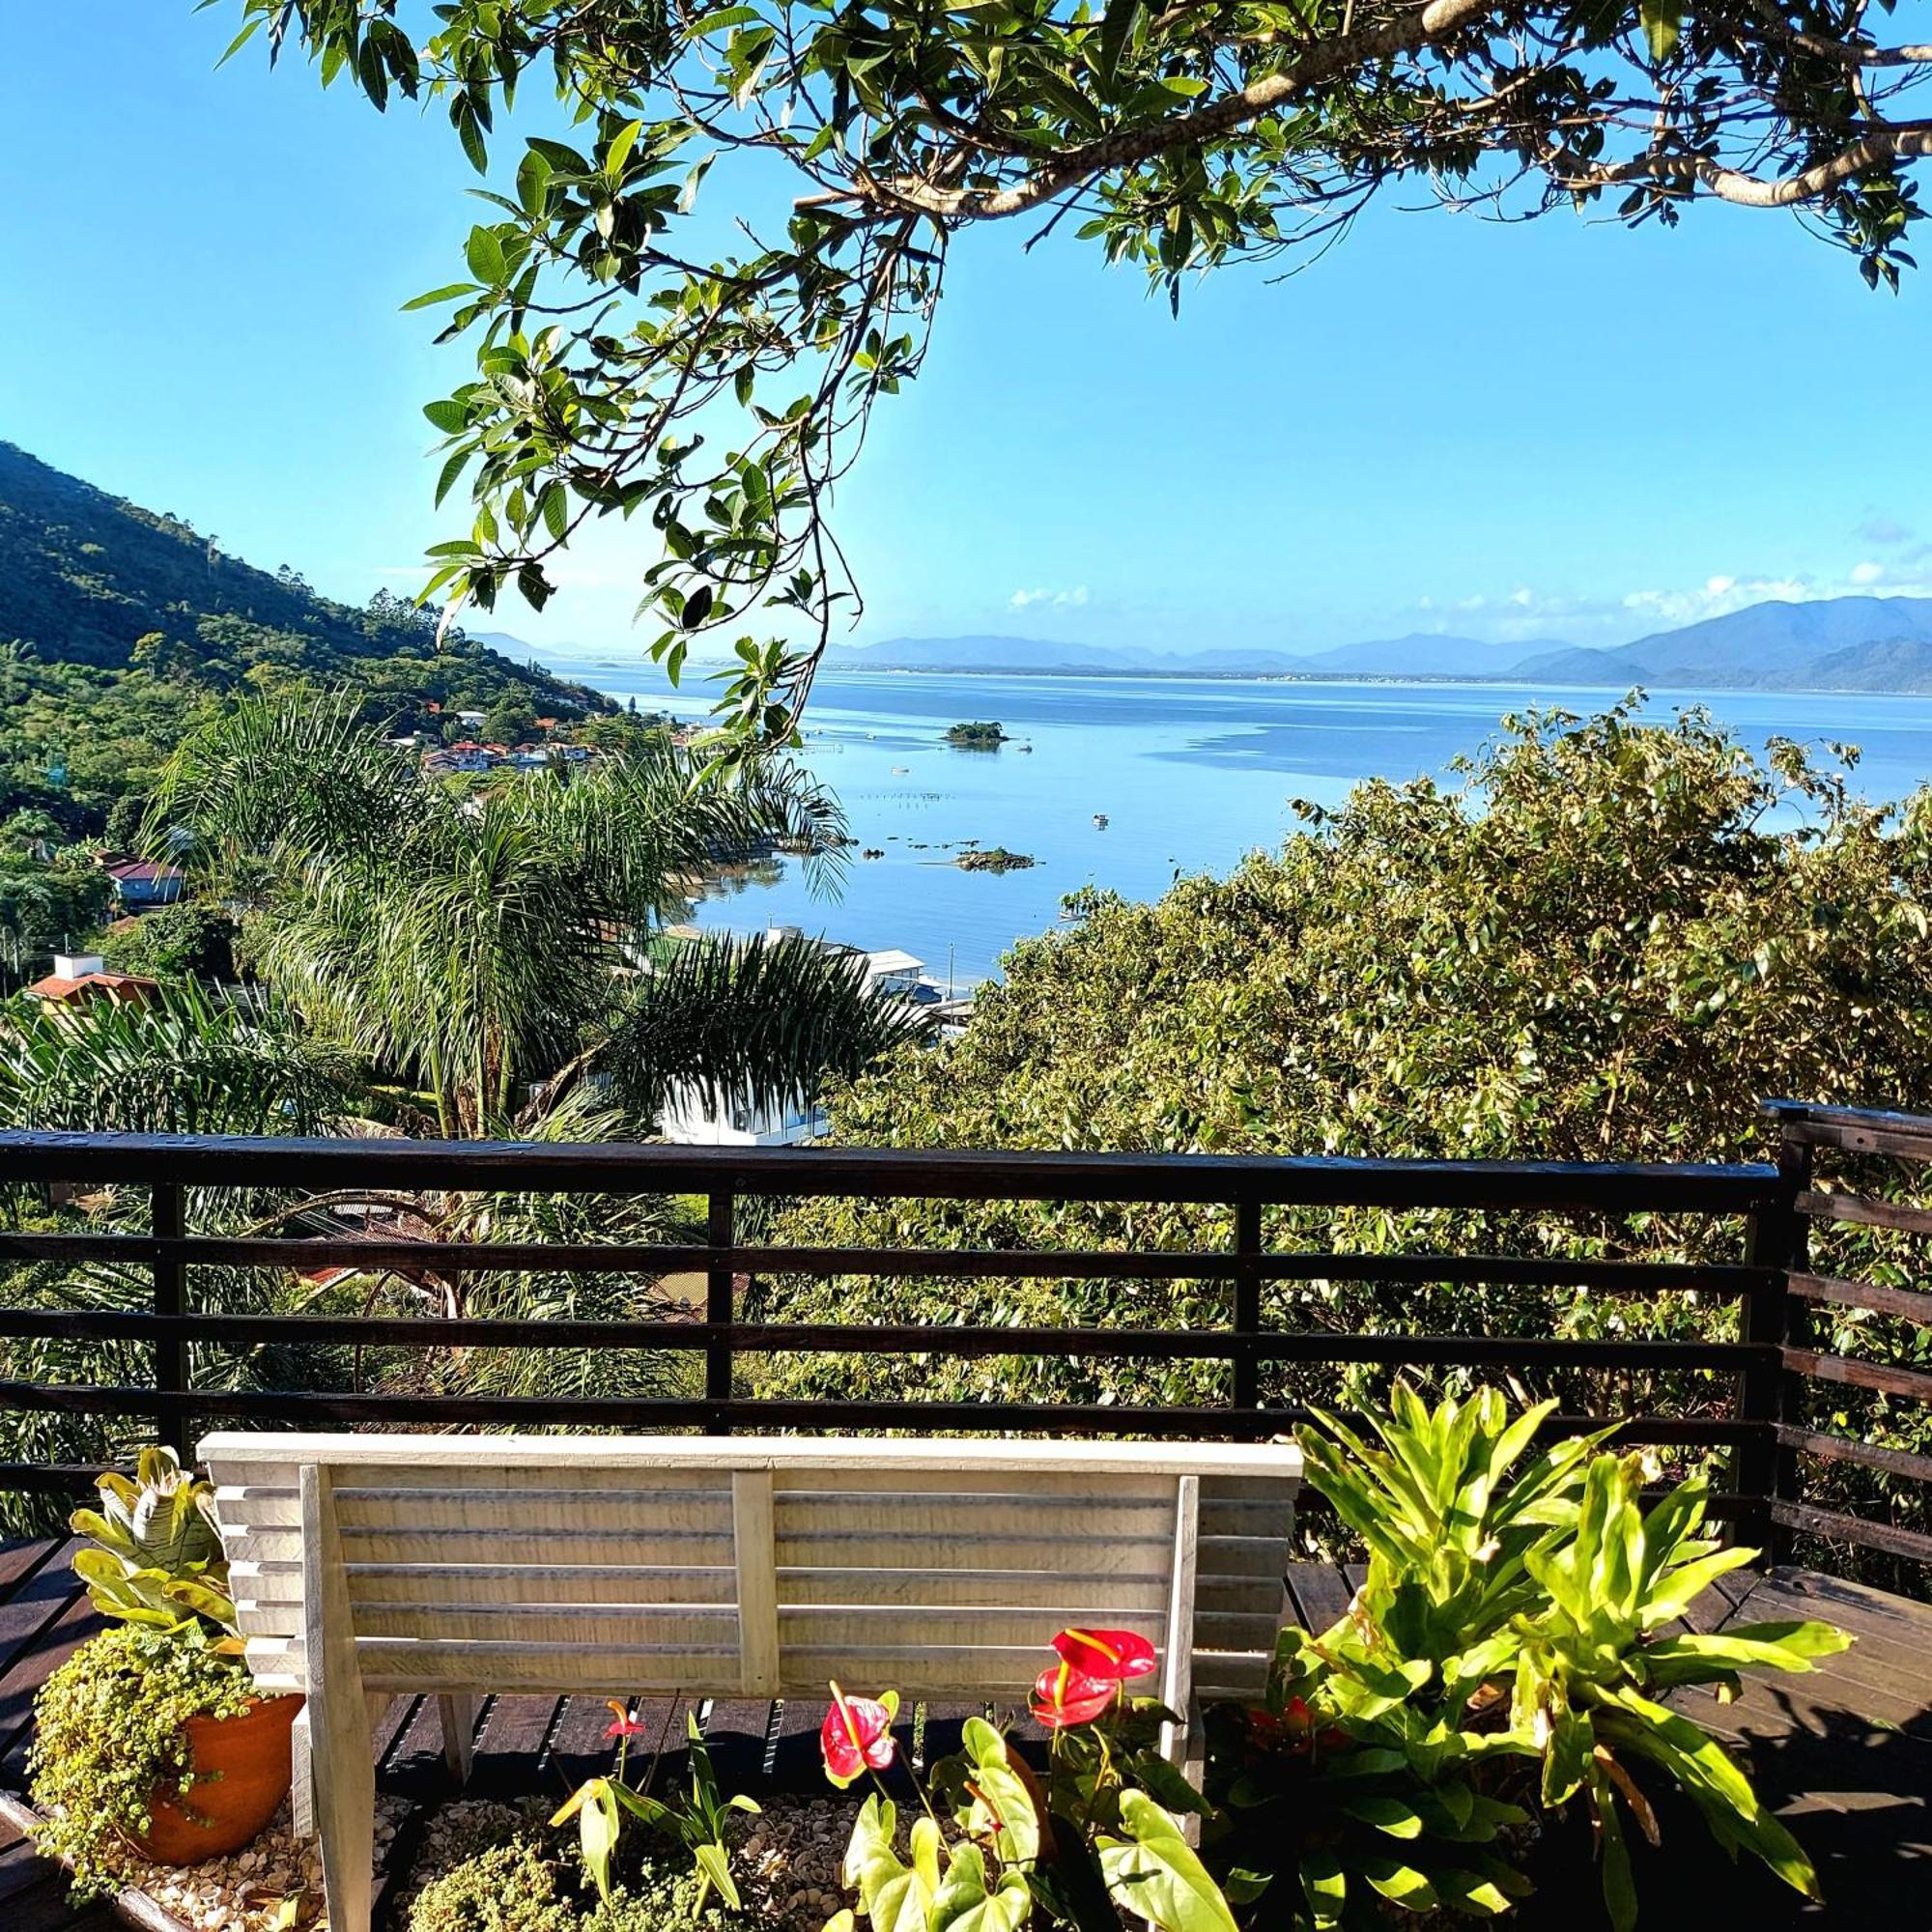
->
xmin=0 ymin=0 xmax=1932 ymax=672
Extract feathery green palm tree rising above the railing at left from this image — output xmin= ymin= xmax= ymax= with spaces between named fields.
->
xmin=151 ymin=697 xmax=920 ymax=1138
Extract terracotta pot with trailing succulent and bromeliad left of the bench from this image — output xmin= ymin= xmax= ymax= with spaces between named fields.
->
xmin=29 ymin=1449 xmax=301 ymax=1895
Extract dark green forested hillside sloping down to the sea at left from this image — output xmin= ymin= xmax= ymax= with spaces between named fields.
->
xmin=0 ymin=442 xmax=609 ymax=837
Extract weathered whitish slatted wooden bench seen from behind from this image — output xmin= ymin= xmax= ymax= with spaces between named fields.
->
xmin=201 ymin=1432 xmax=1300 ymax=1932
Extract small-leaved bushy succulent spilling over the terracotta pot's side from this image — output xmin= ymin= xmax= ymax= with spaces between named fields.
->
xmin=27 ymin=1623 xmax=255 ymax=1899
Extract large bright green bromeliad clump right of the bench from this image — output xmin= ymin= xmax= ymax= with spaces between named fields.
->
xmin=1204 ymin=1385 xmax=1849 ymax=1932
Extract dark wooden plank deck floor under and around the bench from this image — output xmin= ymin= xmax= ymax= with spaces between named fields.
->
xmin=0 ymin=1540 xmax=1932 ymax=1932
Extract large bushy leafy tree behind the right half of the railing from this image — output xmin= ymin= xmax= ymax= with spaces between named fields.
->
xmin=755 ymin=713 xmax=1932 ymax=1584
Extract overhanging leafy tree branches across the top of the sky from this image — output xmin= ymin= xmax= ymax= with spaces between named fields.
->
xmin=230 ymin=0 xmax=1932 ymax=740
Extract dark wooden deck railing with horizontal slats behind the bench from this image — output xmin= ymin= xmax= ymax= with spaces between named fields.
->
xmin=0 ymin=1103 xmax=1932 ymax=1561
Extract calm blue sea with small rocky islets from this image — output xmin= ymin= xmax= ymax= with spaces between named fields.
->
xmin=522 ymin=659 xmax=1932 ymax=987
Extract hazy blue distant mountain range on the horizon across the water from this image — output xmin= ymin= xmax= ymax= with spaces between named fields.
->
xmin=827 ymin=597 xmax=1932 ymax=692
